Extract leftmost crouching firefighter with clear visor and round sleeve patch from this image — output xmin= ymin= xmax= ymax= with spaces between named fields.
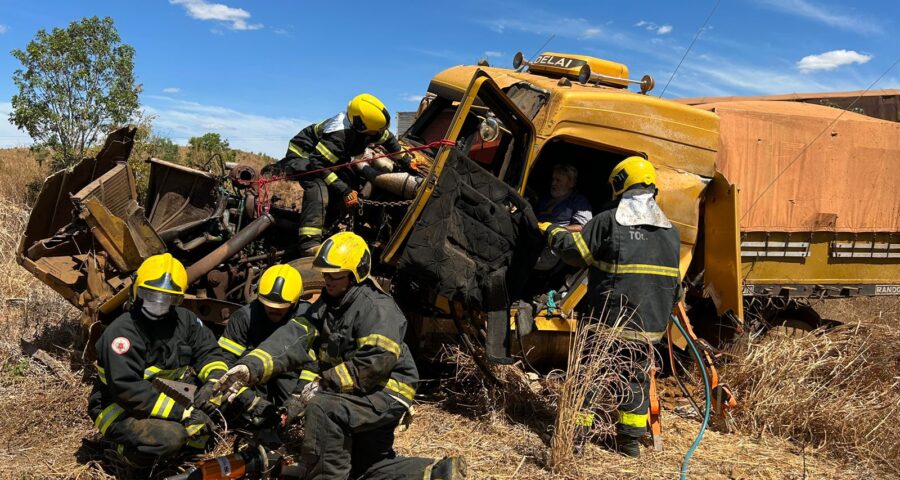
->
xmin=88 ymin=253 xmax=228 ymax=467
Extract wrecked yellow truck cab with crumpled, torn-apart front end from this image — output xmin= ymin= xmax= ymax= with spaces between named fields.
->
xmin=18 ymin=53 xmax=900 ymax=363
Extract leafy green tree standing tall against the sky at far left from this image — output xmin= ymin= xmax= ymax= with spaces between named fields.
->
xmin=9 ymin=17 xmax=141 ymax=167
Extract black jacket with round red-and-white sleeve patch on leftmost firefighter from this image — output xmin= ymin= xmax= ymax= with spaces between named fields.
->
xmin=88 ymin=308 xmax=228 ymax=433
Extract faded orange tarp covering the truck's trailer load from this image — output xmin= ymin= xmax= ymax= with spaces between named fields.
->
xmin=698 ymin=101 xmax=900 ymax=232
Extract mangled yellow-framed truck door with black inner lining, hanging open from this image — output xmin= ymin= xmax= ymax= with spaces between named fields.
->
xmin=383 ymin=70 xmax=543 ymax=355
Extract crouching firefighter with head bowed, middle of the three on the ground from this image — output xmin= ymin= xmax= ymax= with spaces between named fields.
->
xmin=219 ymin=264 xmax=315 ymax=423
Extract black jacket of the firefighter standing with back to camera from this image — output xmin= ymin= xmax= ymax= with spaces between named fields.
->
xmin=547 ymin=208 xmax=681 ymax=342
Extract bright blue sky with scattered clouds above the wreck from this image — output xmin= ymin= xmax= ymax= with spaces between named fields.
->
xmin=0 ymin=0 xmax=900 ymax=157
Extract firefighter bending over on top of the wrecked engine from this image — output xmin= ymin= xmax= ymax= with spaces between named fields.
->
xmin=262 ymin=93 xmax=412 ymax=256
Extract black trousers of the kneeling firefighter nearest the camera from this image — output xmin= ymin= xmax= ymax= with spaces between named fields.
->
xmin=301 ymin=391 xmax=434 ymax=480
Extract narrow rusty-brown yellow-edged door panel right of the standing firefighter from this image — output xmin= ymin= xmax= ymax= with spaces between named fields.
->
xmin=703 ymin=172 xmax=744 ymax=322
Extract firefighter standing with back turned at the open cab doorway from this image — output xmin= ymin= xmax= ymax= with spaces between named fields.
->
xmin=540 ymin=156 xmax=681 ymax=457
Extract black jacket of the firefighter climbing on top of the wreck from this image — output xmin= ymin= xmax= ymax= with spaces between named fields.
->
xmin=270 ymin=113 xmax=401 ymax=196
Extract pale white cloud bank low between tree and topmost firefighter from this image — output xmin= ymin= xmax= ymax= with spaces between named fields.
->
xmin=144 ymin=95 xmax=312 ymax=158
